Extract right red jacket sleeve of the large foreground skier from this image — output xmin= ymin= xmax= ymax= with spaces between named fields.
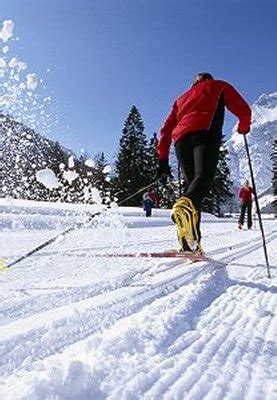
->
xmin=223 ymin=82 xmax=251 ymax=134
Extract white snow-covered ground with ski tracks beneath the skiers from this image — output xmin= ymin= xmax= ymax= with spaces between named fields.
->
xmin=0 ymin=200 xmax=277 ymax=400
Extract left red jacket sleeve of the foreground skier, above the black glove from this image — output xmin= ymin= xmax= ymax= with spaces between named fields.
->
xmin=158 ymin=102 xmax=177 ymax=160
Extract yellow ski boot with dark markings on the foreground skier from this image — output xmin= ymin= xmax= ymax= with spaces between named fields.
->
xmin=171 ymin=196 xmax=198 ymax=254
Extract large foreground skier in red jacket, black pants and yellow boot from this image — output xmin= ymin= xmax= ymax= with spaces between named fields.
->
xmin=158 ymin=73 xmax=251 ymax=253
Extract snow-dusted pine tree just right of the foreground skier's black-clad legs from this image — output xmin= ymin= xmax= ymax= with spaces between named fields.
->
xmin=203 ymin=138 xmax=233 ymax=216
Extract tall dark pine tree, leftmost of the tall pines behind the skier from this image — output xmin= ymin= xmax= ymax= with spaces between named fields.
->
xmin=115 ymin=106 xmax=149 ymax=206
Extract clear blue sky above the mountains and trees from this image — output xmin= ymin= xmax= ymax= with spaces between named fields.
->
xmin=0 ymin=0 xmax=277 ymax=160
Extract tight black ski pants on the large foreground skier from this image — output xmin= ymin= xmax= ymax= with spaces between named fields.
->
xmin=175 ymin=130 xmax=222 ymax=236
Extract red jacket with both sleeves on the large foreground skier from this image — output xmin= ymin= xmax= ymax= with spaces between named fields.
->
xmin=158 ymin=80 xmax=251 ymax=160
